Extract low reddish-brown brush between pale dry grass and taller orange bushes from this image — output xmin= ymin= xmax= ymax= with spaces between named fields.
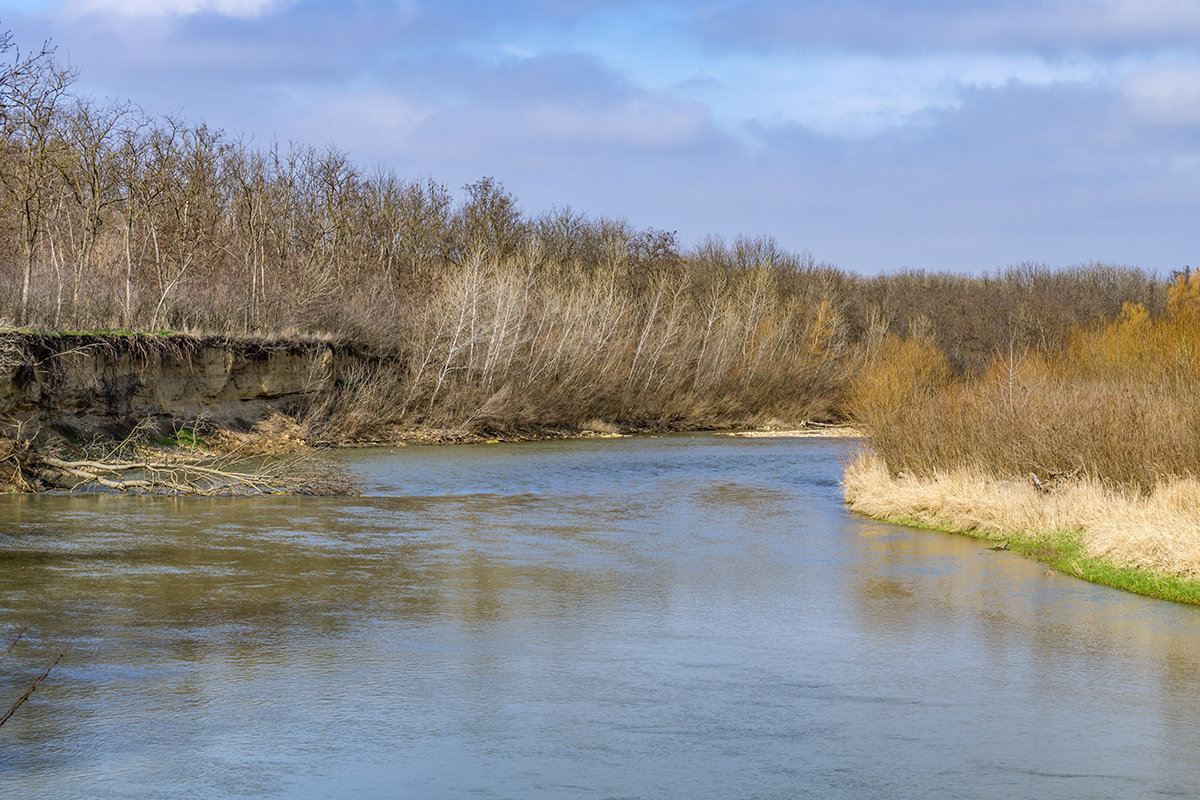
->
xmin=864 ymin=367 xmax=1200 ymax=492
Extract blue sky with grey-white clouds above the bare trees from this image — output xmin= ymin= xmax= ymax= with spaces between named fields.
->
xmin=0 ymin=0 xmax=1200 ymax=275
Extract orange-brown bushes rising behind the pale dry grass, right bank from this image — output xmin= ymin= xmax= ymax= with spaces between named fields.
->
xmin=864 ymin=271 xmax=1200 ymax=491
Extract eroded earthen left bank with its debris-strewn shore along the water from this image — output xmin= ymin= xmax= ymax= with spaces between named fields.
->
xmin=0 ymin=331 xmax=842 ymax=491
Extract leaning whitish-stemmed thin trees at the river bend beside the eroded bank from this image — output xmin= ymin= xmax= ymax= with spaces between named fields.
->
xmin=309 ymin=247 xmax=847 ymax=441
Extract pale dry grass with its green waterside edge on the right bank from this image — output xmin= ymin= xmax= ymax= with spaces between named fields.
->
xmin=842 ymin=453 xmax=1200 ymax=606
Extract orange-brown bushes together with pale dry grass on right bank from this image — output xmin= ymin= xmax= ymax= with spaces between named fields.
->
xmin=845 ymin=270 xmax=1200 ymax=602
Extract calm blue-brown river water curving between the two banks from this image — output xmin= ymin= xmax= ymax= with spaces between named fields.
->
xmin=0 ymin=435 xmax=1200 ymax=799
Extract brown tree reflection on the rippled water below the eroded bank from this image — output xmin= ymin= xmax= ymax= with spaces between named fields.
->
xmin=0 ymin=495 xmax=638 ymax=657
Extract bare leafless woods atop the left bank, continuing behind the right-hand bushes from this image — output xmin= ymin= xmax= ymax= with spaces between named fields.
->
xmin=0 ymin=40 xmax=1163 ymax=434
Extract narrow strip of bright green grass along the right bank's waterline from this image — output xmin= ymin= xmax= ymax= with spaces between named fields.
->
xmin=883 ymin=517 xmax=1200 ymax=606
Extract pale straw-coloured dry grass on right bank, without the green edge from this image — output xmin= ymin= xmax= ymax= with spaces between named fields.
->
xmin=842 ymin=452 xmax=1200 ymax=577
